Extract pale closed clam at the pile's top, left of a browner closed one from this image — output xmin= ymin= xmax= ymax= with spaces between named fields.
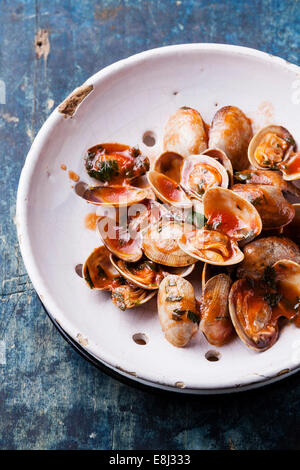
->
xmin=163 ymin=106 xmax=207 ymax=157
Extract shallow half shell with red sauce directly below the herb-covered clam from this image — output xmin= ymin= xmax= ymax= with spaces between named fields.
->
xmin=81 ymin=185 xmax=148 ymax=207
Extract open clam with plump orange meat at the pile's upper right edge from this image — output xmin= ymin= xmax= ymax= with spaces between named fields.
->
xmin=248 ymin=125 xmax=299 ymax=180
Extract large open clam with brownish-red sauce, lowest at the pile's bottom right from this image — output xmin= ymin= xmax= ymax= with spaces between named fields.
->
xmin=229 ymin=279 xmax=278 ymax=352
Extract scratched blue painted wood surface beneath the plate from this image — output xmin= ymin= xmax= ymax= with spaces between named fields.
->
xmin=0 ymin=0 xmax=300 ymax=449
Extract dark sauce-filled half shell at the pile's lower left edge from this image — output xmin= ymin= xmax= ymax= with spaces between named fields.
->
xmin=82 ymin=246 xmax=120 ymax=290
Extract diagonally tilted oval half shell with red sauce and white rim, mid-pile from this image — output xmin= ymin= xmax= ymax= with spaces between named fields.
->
xmin=147 ymin=170 xmax=193 ymax=208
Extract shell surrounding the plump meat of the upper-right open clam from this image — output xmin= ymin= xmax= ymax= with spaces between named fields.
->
xmin=248 ymin=125 xmax=295 ymax=169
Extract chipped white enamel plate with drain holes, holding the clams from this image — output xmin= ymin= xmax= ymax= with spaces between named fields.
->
xmin=17 ymin=44 xmax=300 ymax=393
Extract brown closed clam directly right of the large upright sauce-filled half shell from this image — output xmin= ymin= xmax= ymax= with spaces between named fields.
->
xmin=231 ymin=184 xmax=295 ymax=230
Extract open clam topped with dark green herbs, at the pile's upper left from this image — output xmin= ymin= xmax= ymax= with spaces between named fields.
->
xmin=85 ymin=143 xmax=150 ymax=185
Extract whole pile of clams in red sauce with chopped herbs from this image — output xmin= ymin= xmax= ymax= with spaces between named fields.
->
xmin=80 ymin=106 xmax=300 ymax=352
